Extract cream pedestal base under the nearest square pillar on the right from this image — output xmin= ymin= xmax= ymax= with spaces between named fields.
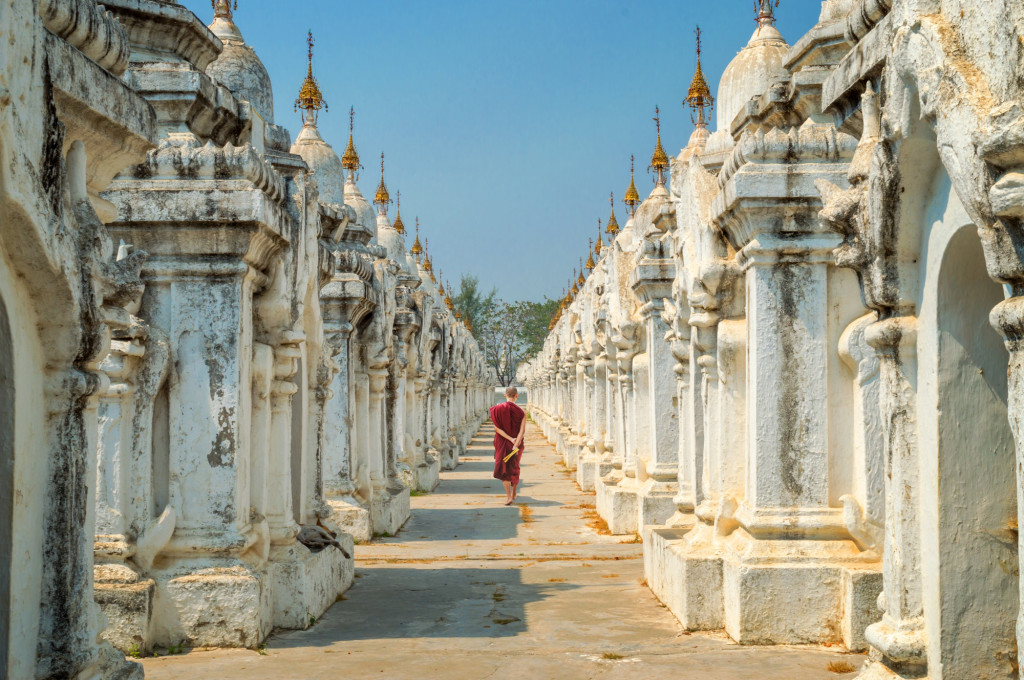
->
xmin=722 ymin=529 xmax=881 ymax=644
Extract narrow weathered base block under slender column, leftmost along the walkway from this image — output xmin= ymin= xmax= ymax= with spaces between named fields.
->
xmin=92 ymin=564 xmax=156 ymax=654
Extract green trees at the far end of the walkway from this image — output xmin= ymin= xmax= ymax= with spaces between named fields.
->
xmin=452 ymin=274 xmax=558 ymax=386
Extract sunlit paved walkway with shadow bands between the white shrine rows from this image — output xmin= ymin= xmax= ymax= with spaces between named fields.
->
xmin=144 ymin=426 xmax=863 ymax=680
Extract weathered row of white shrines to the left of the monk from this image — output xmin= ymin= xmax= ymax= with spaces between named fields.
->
xmin=0 ymin=0 xmax=494 ymax=679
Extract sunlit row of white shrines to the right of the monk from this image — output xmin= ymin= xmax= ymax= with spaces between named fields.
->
xmin=519 ymin=0 xmax=1024 ymax=679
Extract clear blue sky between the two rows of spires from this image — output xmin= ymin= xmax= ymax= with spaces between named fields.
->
xmin=182 ymin=0 xmax=821 ymax=299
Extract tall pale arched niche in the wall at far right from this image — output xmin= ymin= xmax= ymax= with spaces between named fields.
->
xmin=918 ymin=161 xmax=1019 ymax=679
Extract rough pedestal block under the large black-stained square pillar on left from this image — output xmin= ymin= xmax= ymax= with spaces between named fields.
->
xmin=152 ymin=558 xmax=273 ymax=647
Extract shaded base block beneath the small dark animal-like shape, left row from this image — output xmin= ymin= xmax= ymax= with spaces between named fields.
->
xmin=267 ymin=534 xmax=353 ymax=630
